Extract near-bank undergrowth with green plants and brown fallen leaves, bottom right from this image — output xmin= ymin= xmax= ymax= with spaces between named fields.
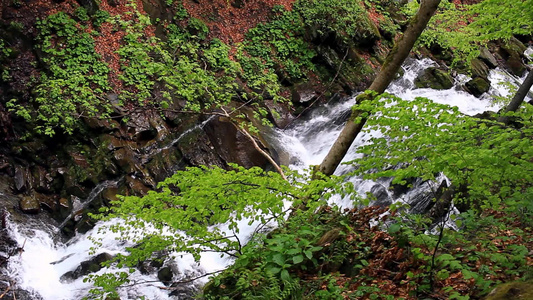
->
xmin=203 ymin=207 xmax=533 ymax=299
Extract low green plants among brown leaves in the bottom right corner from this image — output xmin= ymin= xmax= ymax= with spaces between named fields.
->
xmin=386 ymin=210 xmax=532 ymax=299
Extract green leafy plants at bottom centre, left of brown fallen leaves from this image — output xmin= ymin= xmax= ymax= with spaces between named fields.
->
xmin=203 ymin=211 xmax=336 ymax=299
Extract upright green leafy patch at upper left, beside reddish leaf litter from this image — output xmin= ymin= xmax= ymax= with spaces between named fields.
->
xmin=7 ymin=11 xmax=110 ymax=136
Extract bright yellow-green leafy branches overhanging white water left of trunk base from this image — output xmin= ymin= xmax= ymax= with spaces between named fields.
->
xmin=86 ymin=165 xmax=334 ymax=290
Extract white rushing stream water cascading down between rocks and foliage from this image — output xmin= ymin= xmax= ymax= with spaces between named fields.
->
xmin=8 ymin=59 xmax=531 ymax=300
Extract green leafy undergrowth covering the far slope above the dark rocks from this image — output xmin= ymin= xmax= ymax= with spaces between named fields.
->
xmin=2 ymin=0 xmax=396 ymax=136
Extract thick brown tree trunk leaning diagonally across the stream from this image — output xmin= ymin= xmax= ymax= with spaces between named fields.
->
xmin=318 ymin=0 xmax=441 ymax=176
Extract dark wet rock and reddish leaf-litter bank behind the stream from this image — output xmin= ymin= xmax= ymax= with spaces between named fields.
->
xmin=0 ymin=1 xmax=524 ymax=298
